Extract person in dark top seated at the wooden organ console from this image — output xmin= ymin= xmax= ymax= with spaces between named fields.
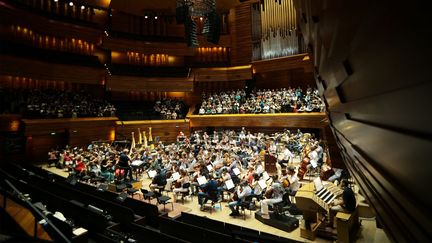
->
xmin=329 ymin=179 xmax=357 ymax=227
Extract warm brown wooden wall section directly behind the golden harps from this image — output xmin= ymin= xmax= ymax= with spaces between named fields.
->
xmin=116 ymin=119 xmax=189 ymax=143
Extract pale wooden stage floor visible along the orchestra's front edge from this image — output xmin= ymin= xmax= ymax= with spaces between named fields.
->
xmin=43 ymin=166 xmax=390 ymax=243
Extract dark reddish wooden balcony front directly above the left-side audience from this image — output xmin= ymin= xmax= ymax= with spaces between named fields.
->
xmin=0 ymin=55 xmax=105 ymax=84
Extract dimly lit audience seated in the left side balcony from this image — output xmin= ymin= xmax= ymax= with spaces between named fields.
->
xmin=0 ymin=89 xmax=116 ymax=118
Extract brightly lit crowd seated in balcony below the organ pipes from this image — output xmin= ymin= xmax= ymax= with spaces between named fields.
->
xmin=198 ymin=88 xmax=324 ymax=115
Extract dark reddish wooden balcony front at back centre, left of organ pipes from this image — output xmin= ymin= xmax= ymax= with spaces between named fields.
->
xmin=107 ymin=75 xmax=193 ymax=92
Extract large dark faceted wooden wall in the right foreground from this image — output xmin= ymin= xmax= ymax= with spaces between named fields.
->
xmin=295 ymin=0 xmax=432 ymax=242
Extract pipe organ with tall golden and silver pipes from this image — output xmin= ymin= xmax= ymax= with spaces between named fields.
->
xmin=252 ymin=0 xmax=304 ymax=60
